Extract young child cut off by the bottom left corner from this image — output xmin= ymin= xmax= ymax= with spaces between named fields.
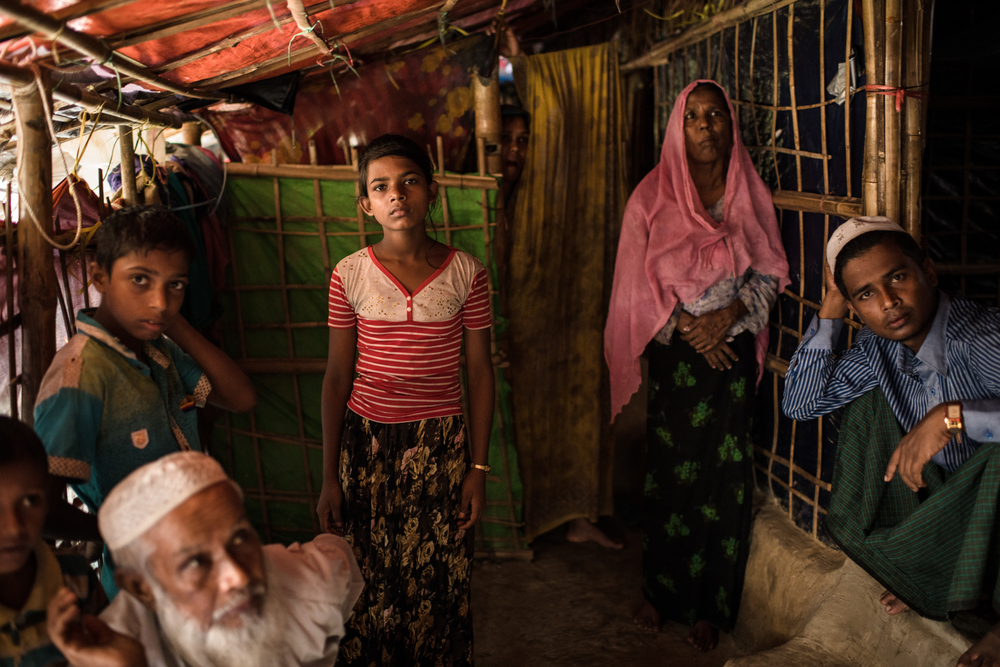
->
xmin=0 ymin=417 xmax=106 ymax=667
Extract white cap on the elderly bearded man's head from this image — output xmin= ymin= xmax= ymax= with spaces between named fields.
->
xmin=97 ymin=451 xmax=243 ymax=551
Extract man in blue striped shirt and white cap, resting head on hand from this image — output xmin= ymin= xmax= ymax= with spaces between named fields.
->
xmin=782 ymin=218 xmax=1000 ymax=664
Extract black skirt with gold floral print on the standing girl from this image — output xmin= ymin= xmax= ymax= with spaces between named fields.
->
xmin=337 ymin=410 xmax=473 ymax=667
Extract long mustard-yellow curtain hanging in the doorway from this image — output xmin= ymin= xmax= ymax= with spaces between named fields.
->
xmin=507 ymin=44 xmax=626 ymax=540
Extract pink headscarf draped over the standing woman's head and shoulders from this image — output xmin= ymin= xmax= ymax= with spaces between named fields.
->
xmin=604 ymin=79 xmax=789 ymax=421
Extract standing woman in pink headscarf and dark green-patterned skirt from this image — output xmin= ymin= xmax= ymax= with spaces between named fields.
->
xmin=604 ymin=81 xmax=788 ymax=651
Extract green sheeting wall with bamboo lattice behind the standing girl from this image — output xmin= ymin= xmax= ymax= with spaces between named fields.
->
xmin=212 ymin=178 xmax=526 ymax=551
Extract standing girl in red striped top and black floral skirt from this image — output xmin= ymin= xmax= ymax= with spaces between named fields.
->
xmin=317 ymin=134 xmax=493 ymax=667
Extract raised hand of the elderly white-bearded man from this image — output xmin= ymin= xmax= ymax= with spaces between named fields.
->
xmin=46 ymin=588 xmax=146 ymax=667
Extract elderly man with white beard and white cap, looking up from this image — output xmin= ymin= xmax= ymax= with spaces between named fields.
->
xmin=48 ymin=452 xmax=364 ymax=667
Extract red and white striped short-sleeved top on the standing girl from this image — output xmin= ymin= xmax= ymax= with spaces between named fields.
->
xmin=329 ymin=246 xmax=490 ymax=424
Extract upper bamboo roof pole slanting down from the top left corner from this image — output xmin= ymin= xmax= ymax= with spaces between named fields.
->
xmin=0 ymin=0 xmax=229 ymax=100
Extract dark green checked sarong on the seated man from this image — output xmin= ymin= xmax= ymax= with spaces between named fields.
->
xmin=827 ymin=389 xmax=1000 ymax=620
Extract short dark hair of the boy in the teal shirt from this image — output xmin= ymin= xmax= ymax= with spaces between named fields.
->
xmin=95 ymin=206 xmax=195 ymax=274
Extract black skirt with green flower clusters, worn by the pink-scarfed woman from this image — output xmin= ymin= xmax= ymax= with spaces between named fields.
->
xmin=642 ymin=333 xmax=757 ymax=631
